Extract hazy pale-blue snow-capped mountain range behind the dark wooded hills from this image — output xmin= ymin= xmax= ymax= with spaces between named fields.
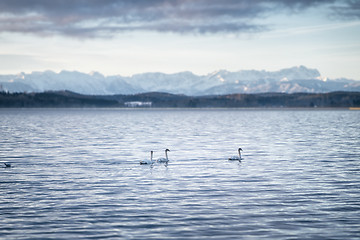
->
xmin=0 ymin=66 xmax=360 ymax=96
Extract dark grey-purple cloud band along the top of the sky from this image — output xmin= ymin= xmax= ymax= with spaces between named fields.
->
xmin=0 ymin=0 xmax=354 ymax=38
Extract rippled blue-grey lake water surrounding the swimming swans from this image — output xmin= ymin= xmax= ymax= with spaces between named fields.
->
xmin=0 ymin=109 xmax=360 ymax=239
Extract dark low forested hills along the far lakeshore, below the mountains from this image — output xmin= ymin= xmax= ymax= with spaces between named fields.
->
xmin=0 ymin=91 xmax=360 ymax=108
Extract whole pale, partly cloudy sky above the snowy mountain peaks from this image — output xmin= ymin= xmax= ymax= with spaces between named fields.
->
xmin=0 ymin=0 xmax=360 ymax=80
